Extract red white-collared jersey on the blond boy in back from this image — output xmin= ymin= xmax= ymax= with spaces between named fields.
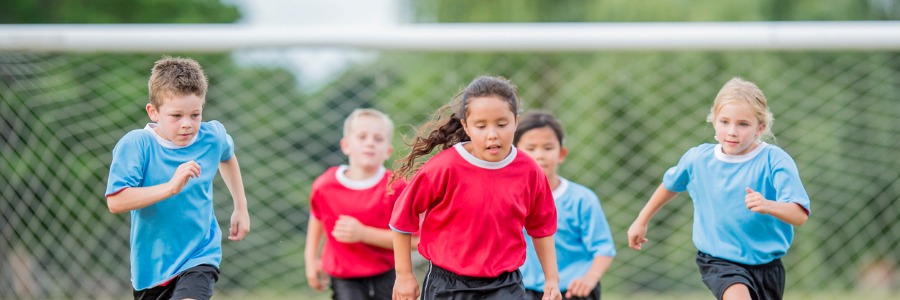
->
xmin=310 ymin=166 xmax=406 ymax=278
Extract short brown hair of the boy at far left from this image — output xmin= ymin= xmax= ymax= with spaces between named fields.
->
xmin=147 ymin=56 xmax=208 ymax=108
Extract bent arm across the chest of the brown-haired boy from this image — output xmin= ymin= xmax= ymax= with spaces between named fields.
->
xmin=106 ymin=160 xmax=200 ymax=214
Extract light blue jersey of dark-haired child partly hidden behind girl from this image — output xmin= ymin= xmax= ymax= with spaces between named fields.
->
xmin=520 ymin=178 xmax=616 ymax=291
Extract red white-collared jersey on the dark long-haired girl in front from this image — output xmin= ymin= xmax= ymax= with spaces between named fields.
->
xmin=391 ymin=143 xmax=556 ymax=277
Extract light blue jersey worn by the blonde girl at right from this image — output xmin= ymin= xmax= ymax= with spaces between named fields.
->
xmin=663 ymin=143 xmax=810 ymax=265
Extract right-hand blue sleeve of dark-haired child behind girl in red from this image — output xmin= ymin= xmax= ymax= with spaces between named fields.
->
xmin=579 ymin=193 xmax=616 ymax=257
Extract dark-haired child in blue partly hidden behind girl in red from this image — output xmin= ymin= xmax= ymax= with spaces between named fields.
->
xmin=513 ymin=112 xmax=616 ymax=300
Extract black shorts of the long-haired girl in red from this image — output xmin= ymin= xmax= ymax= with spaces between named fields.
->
xmin=422 ymin=264 xmax=525 ymax=300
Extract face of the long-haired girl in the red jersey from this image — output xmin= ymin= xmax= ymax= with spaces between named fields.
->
xmin=461 ymin=96 xmax=518 ymax=162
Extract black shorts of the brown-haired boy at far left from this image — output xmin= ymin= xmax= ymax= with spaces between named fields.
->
xmin=133 ymin=265 xmax=219 ymax=300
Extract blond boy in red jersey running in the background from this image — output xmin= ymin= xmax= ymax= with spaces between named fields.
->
xmin=304 ymin=109 xmax=406 ymax=300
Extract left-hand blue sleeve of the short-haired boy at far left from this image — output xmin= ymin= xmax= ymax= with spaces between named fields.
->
xmin=105 ymin=130 xmax=147 ymax=197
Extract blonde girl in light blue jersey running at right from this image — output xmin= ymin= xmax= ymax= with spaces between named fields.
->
xmin=628 ymin=78 xmax=810 ymax=299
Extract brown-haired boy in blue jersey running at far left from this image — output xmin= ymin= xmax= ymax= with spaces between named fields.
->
xmin=106 ymin=57 xmax=250 ymax=299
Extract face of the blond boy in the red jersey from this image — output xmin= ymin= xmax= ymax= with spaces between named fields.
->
xmin=341 ymin=116 xmax=393 ymax=169
